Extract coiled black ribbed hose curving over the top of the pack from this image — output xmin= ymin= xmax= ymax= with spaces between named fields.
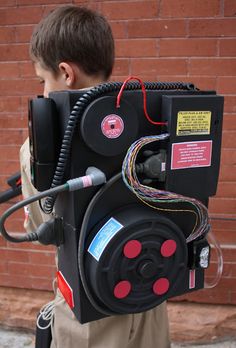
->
xmin=43 ymin=82 xmax=196 ymax=214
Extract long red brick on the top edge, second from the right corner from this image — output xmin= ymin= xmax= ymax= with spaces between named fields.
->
xmin=160 ymin=0 xmax=220 ymax=18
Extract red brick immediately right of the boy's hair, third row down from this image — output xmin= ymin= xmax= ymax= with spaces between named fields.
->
xmin=116 ymin=39 xmax=157 ymax=57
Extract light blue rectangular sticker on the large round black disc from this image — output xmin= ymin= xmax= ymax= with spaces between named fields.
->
xmin=88 ymin=218 xmax=123 ymax=261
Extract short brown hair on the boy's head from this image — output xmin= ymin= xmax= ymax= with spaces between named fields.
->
xmin=30 ymin=6 xmax=114 ymax=79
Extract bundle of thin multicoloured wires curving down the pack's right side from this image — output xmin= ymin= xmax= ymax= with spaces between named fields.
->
xmin=122 ymin=133 xmax=209 ymax=243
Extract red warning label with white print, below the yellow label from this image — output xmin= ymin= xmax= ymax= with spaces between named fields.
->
xmin=171 ymin=140 xmax=212 ymax=169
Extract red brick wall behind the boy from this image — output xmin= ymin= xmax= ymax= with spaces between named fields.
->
xmin=0 ymin=0 xmax=236 ymax=304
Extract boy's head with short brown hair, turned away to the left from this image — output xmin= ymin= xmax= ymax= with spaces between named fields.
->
xmin=30 ymin=6 xmax=114 ymax=95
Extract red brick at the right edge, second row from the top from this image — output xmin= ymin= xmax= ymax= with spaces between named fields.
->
xmin=189 ymin=18 xmax=236 ymax=37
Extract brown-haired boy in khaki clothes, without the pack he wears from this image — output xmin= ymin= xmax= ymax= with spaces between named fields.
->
xmin=21 ymin=6 xmax=170 ymax=348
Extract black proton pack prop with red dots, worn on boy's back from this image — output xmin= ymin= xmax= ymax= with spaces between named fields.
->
xmin=0 ymin=78 xmax=223 ymax=323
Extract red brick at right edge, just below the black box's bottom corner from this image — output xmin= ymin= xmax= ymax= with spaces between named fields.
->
xmin=209 ymin=198 xmax=236 ymax=214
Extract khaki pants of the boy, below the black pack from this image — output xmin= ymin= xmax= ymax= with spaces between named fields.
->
xmin=51 ymin=295 xmax=170 ymax=348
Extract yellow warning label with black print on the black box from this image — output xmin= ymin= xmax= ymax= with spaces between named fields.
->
xmin=176 ymin=111 xmax=211 ymax=135
